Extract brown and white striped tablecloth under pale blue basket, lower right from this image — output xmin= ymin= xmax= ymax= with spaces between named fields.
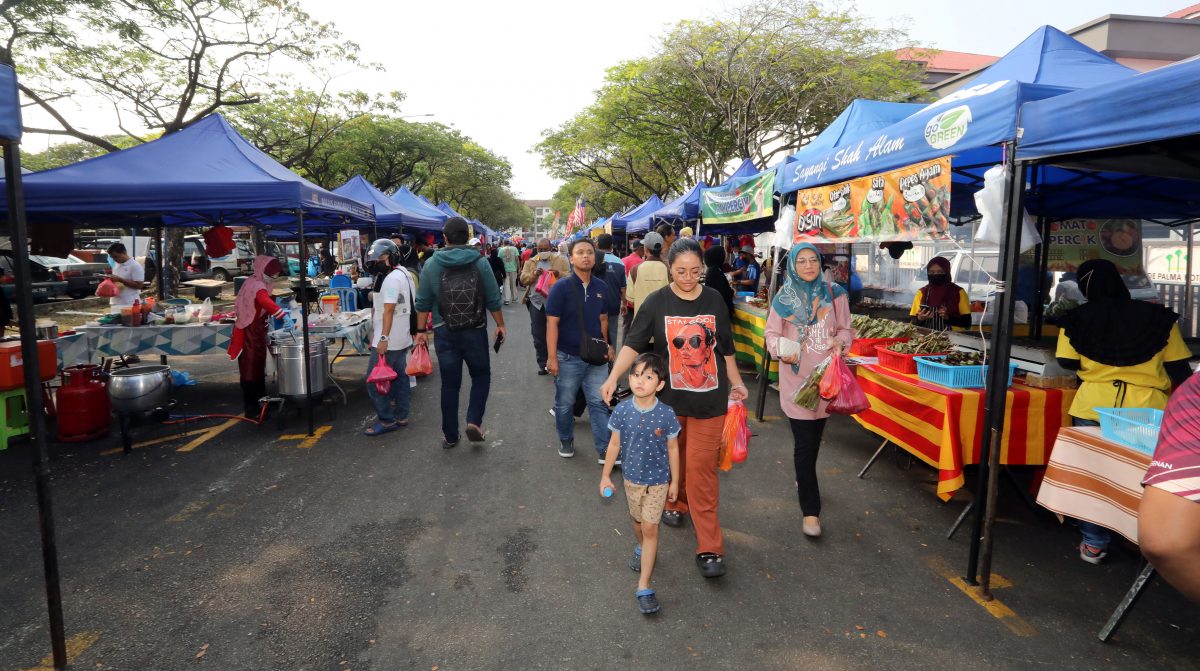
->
xmin=1038 ymin=426 xmax=1151 ymax=543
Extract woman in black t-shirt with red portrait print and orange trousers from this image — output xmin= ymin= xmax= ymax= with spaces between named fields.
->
xmin=600 ymin=239 xmax=748 ymax=577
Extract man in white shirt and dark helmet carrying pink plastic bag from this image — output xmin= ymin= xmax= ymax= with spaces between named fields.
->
xmin=366 ymin=239 xmax=416 ymax=436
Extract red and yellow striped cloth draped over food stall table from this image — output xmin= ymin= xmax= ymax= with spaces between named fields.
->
xmin=853 ymin=365 xmax=1075 ymax=501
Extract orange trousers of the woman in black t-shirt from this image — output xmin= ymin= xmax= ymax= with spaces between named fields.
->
xmin=667 ymin=417 xmax=725 ymax=555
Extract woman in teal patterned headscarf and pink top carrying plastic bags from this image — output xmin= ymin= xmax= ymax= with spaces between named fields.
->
xmin=763 ymin=242 xmax=854 ymax=538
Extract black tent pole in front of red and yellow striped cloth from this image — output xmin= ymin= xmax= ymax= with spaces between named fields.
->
xmin=966 ymin=143 xmax=1026 ymax=599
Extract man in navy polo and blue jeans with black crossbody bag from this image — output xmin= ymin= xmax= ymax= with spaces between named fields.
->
xmin=546 ymin=238 xmax=613 ymax=463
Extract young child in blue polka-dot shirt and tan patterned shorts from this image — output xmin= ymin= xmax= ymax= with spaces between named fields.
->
xmin=600 ymin=352 xmax=680 ymax=615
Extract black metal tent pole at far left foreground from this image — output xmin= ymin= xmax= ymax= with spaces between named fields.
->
xmin=4 ymin=142 xmax=67 ymax=670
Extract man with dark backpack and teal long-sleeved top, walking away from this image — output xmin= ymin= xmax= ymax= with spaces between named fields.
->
xmin=415 ymin=217 xmax=505 ymax=449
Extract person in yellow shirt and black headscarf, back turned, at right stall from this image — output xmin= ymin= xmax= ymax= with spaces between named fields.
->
xmin=1055 ymin=259 xmax=1192 ymax=564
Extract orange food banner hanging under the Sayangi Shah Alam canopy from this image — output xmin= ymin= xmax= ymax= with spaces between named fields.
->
xmin=796 ymin=156 xmax=950 ymax=242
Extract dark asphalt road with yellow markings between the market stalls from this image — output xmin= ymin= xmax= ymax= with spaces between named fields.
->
xmin=0 ymin=306 xmax=1200 ymax=671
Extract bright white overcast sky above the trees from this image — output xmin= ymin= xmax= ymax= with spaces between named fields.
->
xmin=49 ymin=0 xmax=1189 ymax=198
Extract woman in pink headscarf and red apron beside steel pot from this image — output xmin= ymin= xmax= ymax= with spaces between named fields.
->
xmin=228 ymin=256 xmax=293 ymax=418
